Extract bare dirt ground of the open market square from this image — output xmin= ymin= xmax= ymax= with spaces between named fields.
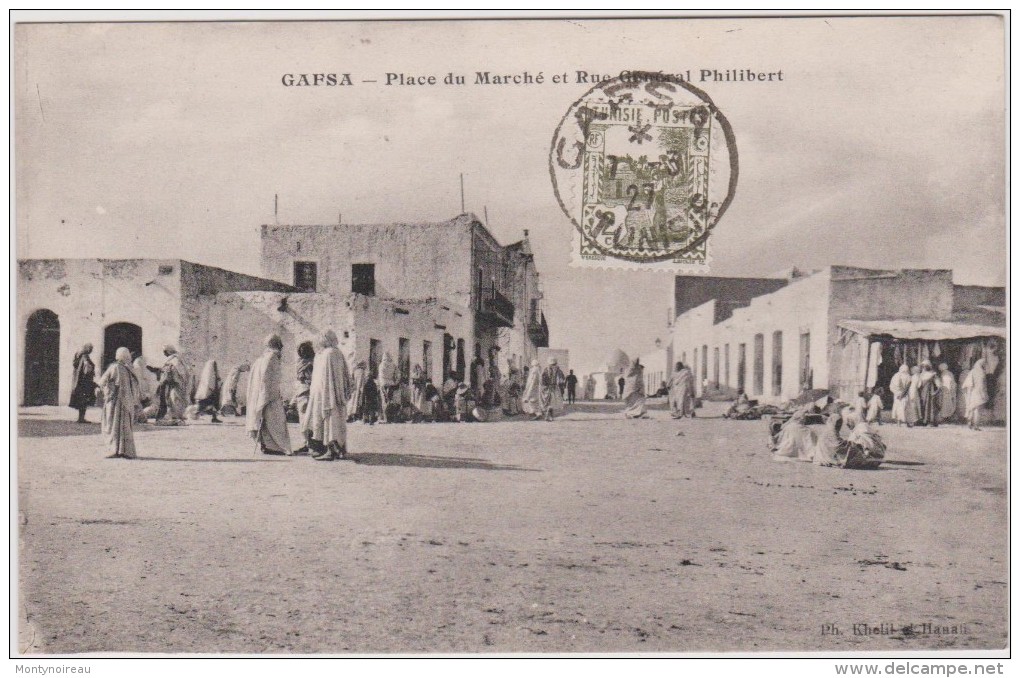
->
xmin=17 ymin=404 xmax=1008 ymax=654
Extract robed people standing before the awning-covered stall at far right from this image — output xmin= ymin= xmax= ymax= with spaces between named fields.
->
xmin=876 ymin=358 xmax=988 ymax=430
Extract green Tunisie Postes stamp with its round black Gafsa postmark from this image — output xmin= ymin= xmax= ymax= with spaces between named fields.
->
xmin=549 ymin=71 xmax=737 ymax=272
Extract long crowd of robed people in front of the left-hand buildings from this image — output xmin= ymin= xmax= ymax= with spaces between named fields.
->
xmin=69 ymin=330 xmax=591 ymax=461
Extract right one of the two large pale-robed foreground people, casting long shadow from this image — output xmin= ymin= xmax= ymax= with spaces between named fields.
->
xmin=302 ymin=329 xmax=352 ymax=462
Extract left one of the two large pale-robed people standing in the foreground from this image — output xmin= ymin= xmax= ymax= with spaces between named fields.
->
xmin=245 ymin=334 xmax=291 ymax=455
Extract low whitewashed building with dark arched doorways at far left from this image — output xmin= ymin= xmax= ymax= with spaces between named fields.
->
xmin=17 ymin=259 xmax=293 ymax=405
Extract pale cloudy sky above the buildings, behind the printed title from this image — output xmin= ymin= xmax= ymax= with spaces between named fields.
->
xmin=14 ymin=16 xmax=1008 ymax=373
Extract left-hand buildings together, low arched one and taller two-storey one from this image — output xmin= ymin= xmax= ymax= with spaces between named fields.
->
xmin=17 ymin=214 xmax=549 ymax=405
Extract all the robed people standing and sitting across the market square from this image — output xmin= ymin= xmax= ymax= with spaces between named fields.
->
xmin=61 ymin=330 xmax=988 ymax=467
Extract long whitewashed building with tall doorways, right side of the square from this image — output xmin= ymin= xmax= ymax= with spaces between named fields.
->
xmin=672 ymin=266 xmax=1005 ymax=415
